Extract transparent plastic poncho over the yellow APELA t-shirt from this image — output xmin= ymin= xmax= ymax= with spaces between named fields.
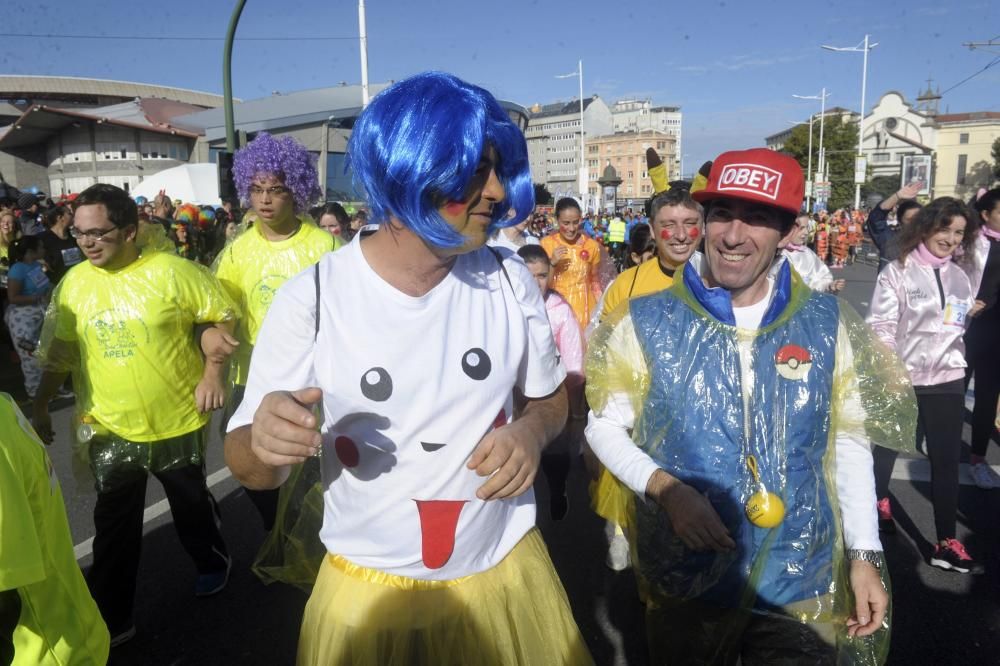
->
xmin=36 ymin=246 xmax=239 ymax=490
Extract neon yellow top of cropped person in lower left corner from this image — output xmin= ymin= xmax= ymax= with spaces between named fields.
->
xmin=0 ymin=393 xmax=111 ymax=666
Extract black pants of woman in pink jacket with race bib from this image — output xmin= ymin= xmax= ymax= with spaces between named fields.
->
xmin=872 ymin=380 xmax=965 ymax=540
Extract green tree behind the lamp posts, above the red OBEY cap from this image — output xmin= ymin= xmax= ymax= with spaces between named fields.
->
xmin=783 ymin=116 xmax=864 ymax=210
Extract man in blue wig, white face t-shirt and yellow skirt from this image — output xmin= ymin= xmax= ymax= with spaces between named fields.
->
xmin=225 ymin=73 xmax=591 ymax=665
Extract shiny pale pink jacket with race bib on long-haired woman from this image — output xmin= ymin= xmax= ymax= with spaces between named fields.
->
xmin=866 ymin=252 xmax=975 ymax=386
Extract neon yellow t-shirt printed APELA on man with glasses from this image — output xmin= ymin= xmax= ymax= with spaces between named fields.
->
xmin=49 ymin=252 xmax=239 ymax=442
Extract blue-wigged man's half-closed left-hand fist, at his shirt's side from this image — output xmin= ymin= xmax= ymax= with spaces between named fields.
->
xmin=250 ymin=387 xmax=323 ymax=467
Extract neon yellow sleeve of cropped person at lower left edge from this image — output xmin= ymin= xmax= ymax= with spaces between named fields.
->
xmin=0 ymin=395 xmax=48 ymax=590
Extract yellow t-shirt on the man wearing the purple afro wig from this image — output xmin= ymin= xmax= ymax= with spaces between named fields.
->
xmin=215 ymin=221 xmax=341 ymax=385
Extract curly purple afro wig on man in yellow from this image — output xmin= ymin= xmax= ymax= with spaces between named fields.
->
xmin=233 ymin=132 xmax=322 ymax=212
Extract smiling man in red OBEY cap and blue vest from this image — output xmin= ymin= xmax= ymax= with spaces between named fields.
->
xmin=587 ymin=149 xmax=915 ymax=666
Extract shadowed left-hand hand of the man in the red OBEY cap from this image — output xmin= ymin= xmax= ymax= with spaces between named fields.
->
xmin=646 ymin=470 xmax=736 ymax=552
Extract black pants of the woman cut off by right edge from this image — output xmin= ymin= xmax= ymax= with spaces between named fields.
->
xmin=965 ymin=319 xmax=1000 ymax=456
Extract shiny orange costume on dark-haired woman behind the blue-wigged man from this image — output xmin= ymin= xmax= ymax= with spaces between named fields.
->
xmin=541 ymin=232 xmax=602 ymax=328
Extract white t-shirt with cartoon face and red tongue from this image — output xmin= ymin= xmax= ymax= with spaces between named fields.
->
xmin=229 ymin=239 xmax=566 ymax=580
